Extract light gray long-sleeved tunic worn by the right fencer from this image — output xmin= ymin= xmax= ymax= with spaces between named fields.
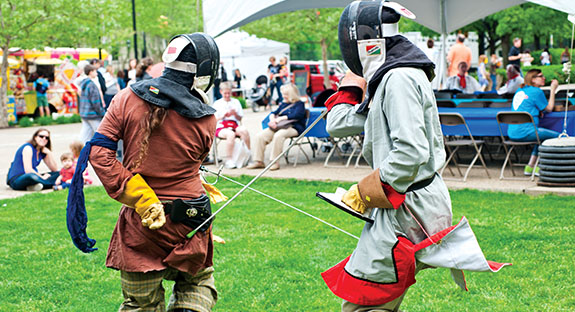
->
xmin=327 ymin=68 xmax=452 ymax=283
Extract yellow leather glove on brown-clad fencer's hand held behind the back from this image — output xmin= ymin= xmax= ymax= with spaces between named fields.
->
xmin=118 ymin=174 xmax=166 ymax=230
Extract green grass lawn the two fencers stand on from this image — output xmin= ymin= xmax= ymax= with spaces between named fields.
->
xmin=0 ymin=177 xmax=575 ymax=312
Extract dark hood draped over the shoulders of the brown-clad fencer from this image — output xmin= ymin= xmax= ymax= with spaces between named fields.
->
xmin=130 ymin=77 xmax=216 ymax=119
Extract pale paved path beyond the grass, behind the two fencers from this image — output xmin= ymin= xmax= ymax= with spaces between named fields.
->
xmin=0 ymin=110 xmax=575 ymax=200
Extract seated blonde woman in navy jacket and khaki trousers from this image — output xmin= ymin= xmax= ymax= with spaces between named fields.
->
xmin=247 ymin=83 xmax=306 ymax=170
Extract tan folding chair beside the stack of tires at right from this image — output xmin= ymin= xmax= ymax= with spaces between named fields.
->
xmin=496 ymin=112 xmax=541 ymax=181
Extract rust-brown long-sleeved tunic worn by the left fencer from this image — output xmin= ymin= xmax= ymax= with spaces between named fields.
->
xmin=90 ymin=88 xmax=216 ymax=274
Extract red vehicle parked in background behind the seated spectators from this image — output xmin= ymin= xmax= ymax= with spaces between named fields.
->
xmin=289 ymin=60 xmax=339 ymax=101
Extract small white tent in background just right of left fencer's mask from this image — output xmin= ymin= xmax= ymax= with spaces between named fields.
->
xmin=215 ymin=31 xmax=289 ymax=88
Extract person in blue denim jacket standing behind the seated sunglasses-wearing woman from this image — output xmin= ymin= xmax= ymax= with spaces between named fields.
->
xmin=78 ymin=65 xmax=106 ymax=143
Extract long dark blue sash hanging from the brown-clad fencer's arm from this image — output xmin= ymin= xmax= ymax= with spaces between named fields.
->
xmin=66 ymin=132 xmax=118 ymax=253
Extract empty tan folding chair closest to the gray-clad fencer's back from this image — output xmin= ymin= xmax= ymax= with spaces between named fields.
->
xmin=439 ymin=113 xmax=491 ymax=182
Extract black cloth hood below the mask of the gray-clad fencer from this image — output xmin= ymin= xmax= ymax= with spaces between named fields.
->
xmin=357 ymin=35 xmax=435 ymax=113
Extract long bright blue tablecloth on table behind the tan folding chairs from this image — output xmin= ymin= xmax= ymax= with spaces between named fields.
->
xmin=438 ymin=107 xmax=575 ymax=136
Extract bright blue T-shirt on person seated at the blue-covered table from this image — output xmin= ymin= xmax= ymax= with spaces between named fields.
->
xmin=507 ymin=86 xmax=548 ymax=140
